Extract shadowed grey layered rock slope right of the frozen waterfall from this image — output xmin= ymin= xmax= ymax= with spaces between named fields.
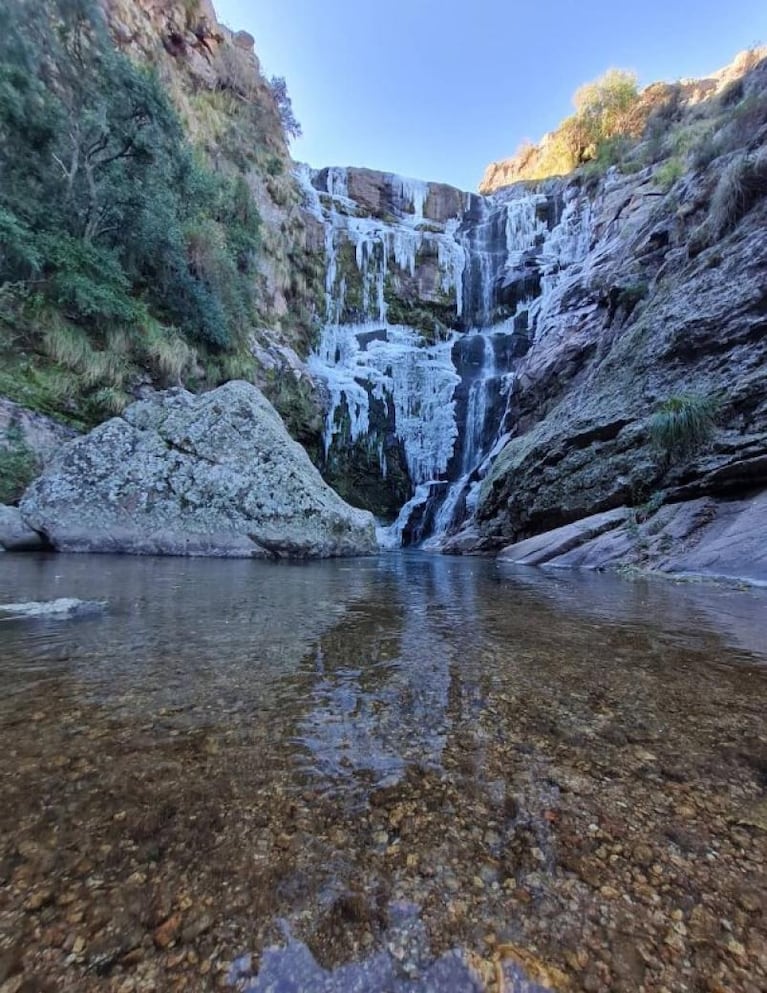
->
xmin=447 ymin=56 xmax=767 ymax=580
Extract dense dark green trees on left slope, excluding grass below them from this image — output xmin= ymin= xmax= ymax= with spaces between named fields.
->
xmin=0 ymin=0 xmax=259 ymax=347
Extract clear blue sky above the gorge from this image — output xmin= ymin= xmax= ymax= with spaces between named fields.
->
xmin=213 ymin=0 xmax=767 ymax=189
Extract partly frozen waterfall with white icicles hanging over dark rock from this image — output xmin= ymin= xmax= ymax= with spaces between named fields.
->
xmin=298 ymin=167 xmax=591 ymax=546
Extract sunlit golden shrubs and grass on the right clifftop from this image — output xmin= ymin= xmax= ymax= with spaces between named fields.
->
xmin=479 ymin=48 xmax=767 ymax=194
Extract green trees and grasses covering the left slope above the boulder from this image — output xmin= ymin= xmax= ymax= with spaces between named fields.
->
xmin=0 ymin=0 xmax=316 ymax=423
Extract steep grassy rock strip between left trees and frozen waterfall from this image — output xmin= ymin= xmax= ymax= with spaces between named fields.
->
xmin=102 ymin=0 xmax=317 ymax=354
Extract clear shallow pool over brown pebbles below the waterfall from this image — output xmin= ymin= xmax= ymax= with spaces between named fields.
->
xmin=0 ymin=553 xmax=767 ymax=993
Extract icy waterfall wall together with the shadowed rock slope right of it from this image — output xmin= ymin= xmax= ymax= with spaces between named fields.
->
xmin=307 ymin=50 xmax=767 ymax=578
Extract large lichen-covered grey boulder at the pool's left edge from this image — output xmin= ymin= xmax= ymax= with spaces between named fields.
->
xmin=20 ymin=382 xmax=376 ymax=558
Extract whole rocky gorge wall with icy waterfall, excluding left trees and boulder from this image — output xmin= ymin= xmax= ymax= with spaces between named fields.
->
xmin=0 ymin=0 xmax=767 ymax=565
